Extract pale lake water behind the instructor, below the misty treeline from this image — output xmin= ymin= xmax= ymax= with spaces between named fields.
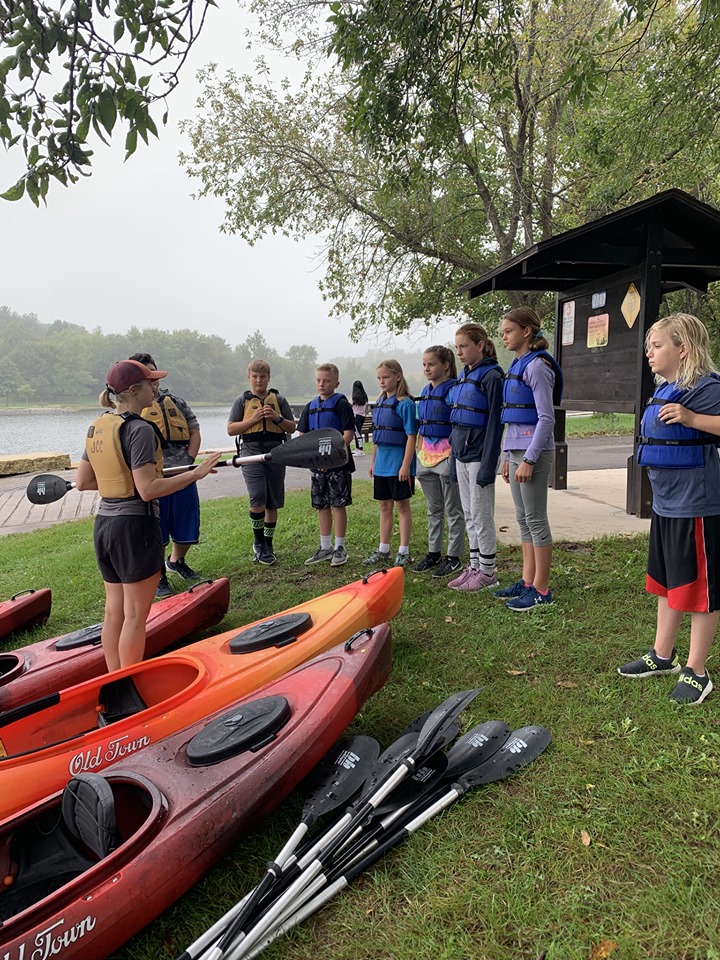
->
xmin=0 ymin=404 xmax=242 ymax=460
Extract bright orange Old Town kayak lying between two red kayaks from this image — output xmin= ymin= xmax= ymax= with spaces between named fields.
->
xmin=0 ymin=567 xmax=404 ymax=819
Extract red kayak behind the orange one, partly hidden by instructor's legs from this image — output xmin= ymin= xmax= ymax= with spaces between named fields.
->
xmin=0 ymin=577 xmax=230 ymax=711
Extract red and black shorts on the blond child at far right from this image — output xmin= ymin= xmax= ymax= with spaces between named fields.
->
xmin=645 ymin=513 xmax=720 ymax=613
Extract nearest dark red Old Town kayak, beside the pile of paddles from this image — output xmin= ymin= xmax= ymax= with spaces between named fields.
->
xmin=0 ymin=624 xmax=391 ymax=960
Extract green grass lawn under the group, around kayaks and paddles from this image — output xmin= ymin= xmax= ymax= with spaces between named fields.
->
xmin=0 ymin=481 xmax=720 ymax=960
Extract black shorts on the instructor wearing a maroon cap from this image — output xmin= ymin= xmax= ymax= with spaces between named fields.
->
xmin=93 ymin=515 xmax=165 ymax=583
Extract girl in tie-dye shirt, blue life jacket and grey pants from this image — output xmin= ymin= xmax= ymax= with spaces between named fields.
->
xmin=413 ymin=345 xmax=465 ymax=580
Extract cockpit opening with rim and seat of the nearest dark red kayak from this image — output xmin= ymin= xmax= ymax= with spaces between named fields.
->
xmin=0 ymin=773 xmax=167 ymax=929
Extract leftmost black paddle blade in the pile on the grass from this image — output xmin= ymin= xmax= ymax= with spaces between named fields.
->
xmin=303 ymin=737 xmax=380 ymax=824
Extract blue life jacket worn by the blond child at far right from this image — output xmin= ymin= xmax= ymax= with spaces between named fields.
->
xmin=637 ymin=373 xmax=720 ymax=470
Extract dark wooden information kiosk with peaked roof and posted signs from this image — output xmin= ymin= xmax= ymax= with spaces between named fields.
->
xmin=463 ymin=190 xmax=720 ymax=517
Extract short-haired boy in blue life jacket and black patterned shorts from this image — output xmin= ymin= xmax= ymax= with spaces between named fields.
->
xmin=298 ymin=363 xmax=355 ymax=567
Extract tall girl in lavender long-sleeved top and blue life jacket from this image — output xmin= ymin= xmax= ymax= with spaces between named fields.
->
xmin=495 ymin=307 xmax=563 ymax=613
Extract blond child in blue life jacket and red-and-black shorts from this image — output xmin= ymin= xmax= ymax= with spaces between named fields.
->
xmin=618 ymin=313 xmax=720 ymax=706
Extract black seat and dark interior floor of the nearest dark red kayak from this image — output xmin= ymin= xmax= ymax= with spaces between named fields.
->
xmin=0 ymin=773 xmax=119 ymax=923
